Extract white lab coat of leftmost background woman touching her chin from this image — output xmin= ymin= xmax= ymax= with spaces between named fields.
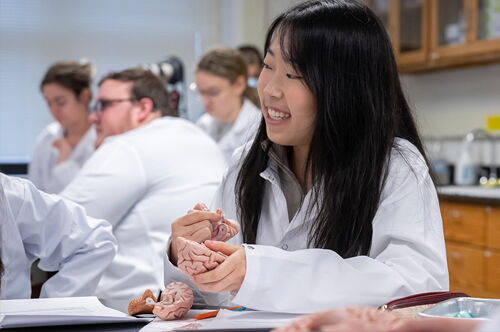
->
xmin=28 ymin=122 xmax=96 ymax=194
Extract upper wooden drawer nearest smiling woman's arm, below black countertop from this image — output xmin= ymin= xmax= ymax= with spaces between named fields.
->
xmin=441 ymin=202 xmax=486 ymax=245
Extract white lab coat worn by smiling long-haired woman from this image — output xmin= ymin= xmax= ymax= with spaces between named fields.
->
xmin=165 ymin=139 xmax=448 ymax=313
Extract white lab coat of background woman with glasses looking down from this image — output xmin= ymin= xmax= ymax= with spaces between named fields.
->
xmin=196 ymin=99 xmax=262 ymax=162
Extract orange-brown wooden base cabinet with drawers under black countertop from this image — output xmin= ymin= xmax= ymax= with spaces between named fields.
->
xmin=440 ymin=200 xmax=500 ymax=298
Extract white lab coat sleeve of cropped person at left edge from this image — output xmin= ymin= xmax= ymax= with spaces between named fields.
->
xmin=0 ymin=173 xmax=116 ymax=299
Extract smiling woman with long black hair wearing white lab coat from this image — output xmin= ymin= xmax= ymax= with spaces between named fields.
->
xmin=165 ymin=0 xmax=448 ymax=313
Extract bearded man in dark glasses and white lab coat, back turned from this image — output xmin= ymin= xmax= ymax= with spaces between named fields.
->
xmin=61 ymin=69 xmax=226 ymax=300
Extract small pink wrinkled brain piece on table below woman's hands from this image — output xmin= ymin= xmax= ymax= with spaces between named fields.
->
xmin=153 ymin=282 xmax=194 ymax=320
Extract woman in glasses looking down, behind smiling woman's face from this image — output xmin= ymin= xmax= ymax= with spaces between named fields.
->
xmin=196 ymin=48 xmax=261 ymax=161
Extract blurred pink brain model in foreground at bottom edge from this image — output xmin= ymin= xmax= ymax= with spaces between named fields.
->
xmin=273 ymin=307 xmax=403 ymax=332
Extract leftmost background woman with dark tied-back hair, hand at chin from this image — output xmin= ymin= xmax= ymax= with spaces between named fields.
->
xmin=28 ymin=62 xmax=96 ymax=193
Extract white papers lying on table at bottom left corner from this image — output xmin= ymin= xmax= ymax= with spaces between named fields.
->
xmin=0 ymin=296 xmax=151 ymax=328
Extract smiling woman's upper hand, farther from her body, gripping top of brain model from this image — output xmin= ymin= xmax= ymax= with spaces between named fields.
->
xmin=169 ymin=204 xmax=221 ymax=266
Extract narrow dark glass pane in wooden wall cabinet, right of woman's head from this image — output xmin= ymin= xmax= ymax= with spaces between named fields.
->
xmin=399 ymin=0 xmax=424 ymax=53
